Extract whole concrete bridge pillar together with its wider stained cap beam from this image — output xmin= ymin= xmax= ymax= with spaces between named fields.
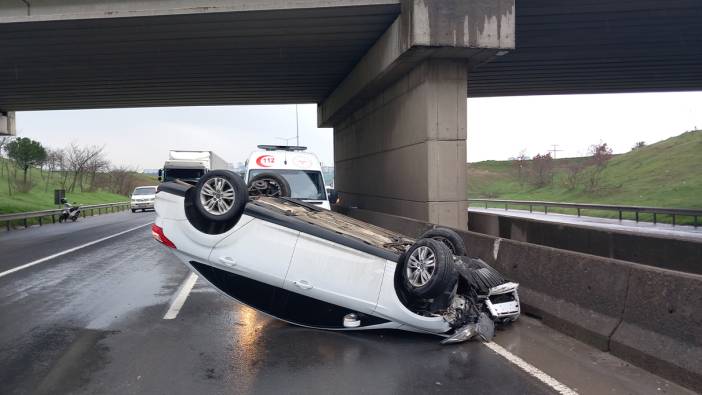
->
xmin=326 ymin=0 xmax=514 ymax=228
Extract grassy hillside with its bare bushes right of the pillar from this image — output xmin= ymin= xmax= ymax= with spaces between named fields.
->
xmin=467 ymin=130 xmax=702 ymax=223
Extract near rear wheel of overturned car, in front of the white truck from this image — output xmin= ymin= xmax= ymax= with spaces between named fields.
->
xmin=185 ymin=170 xmax=249 ymax=234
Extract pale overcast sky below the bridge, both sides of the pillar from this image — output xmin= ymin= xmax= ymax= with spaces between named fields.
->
xmin=12 ymin=92 xmax=702 ymax=169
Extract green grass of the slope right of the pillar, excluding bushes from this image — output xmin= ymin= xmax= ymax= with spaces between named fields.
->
xmin=467 ymin=130 xmax=702 ymax=223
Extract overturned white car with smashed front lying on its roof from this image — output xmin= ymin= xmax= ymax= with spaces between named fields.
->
xmin=152 ymin=170 xmax=520 ymax=343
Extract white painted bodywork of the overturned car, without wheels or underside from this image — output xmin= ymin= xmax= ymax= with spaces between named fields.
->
xmin=155 ymin=183 xmax=519 ymax=336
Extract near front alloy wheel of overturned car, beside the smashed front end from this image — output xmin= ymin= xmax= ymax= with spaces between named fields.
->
xmin=402 ymin=239 xmax=458 ymax=299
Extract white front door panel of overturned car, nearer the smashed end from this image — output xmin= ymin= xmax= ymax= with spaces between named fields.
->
xmin=284 ymin=233 xmax=385 ymax=313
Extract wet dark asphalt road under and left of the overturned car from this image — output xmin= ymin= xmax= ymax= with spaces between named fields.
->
xmin=0 ymin=213 xmax=692 ymax=394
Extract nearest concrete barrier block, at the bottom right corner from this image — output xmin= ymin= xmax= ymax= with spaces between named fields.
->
xmin=610 ymin=266 xmax=702 ymax=392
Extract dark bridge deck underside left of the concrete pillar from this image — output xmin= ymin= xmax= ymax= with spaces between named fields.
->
xmin=0 ymin=5 xmax=400 ymax=110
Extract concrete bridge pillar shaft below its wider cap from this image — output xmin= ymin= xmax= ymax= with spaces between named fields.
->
xmin=334 ymin=59 xmax=468 ymax=228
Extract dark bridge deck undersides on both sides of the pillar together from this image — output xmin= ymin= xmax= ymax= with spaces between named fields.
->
xmin=0 ymin=0 xmax=702 ymax=111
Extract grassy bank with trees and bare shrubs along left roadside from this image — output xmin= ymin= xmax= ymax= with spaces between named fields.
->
xmin=0 ymin=137 xmax=157 ymax=214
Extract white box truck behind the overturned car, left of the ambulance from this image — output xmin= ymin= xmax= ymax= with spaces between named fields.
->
xmin=158 ymin=150 xmax=229 ymax=184
